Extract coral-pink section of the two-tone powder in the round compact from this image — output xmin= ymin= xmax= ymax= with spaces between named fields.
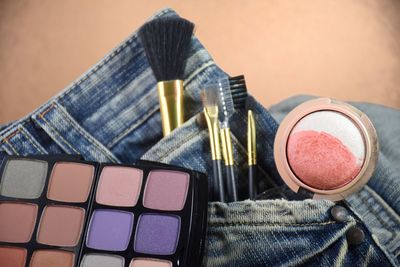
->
xmin=287 ymin=130 xmax=362 ymax=190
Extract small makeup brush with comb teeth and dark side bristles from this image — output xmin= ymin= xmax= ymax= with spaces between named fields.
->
xmin=216 ymin=75 xmax=247 ymax=201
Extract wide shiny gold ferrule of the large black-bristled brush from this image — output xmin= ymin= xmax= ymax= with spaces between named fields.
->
xmin=157 ymin=80 xmax=184 ymax=136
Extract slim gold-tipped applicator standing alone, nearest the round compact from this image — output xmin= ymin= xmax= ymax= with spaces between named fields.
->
xmin=247 ymin=110 xmax=257 ymax=199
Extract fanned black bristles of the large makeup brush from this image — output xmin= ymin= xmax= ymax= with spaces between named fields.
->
xmin=139 ymin=17 xmax=194 ymax=81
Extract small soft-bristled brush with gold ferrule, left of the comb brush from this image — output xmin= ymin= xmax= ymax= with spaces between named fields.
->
xmin=202 ymin=87 xmax=225 ymax=202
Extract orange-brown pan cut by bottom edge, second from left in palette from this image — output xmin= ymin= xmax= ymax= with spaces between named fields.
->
xmin=29 ymin=250 xmax=75 ymax=267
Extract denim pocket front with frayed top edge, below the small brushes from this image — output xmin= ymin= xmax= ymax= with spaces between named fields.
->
xmin=204 ymin=200 xmax=382 ymax=267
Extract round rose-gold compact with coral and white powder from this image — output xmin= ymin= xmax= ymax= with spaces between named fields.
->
xmin=274 ymin=98 xmax=378 ymax=201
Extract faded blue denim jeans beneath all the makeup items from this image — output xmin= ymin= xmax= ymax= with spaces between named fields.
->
xmin=0 ymin=9 xmax=400 ymax=266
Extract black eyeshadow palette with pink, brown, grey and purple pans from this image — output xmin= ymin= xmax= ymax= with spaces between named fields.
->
xmin=0 ymin=155 xmax=208 ymax=267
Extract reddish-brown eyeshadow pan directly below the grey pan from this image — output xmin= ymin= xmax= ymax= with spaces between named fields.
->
xmin=0 ymin=202 xmax=38 ymax=243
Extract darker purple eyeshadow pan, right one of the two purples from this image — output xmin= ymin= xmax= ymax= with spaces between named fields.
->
xmin=134 ymin=214 xmax=181 ymax=255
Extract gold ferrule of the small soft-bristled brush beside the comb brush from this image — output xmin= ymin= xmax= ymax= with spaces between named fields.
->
xmin=204 ymin=106 xmax=221 ymax=160
